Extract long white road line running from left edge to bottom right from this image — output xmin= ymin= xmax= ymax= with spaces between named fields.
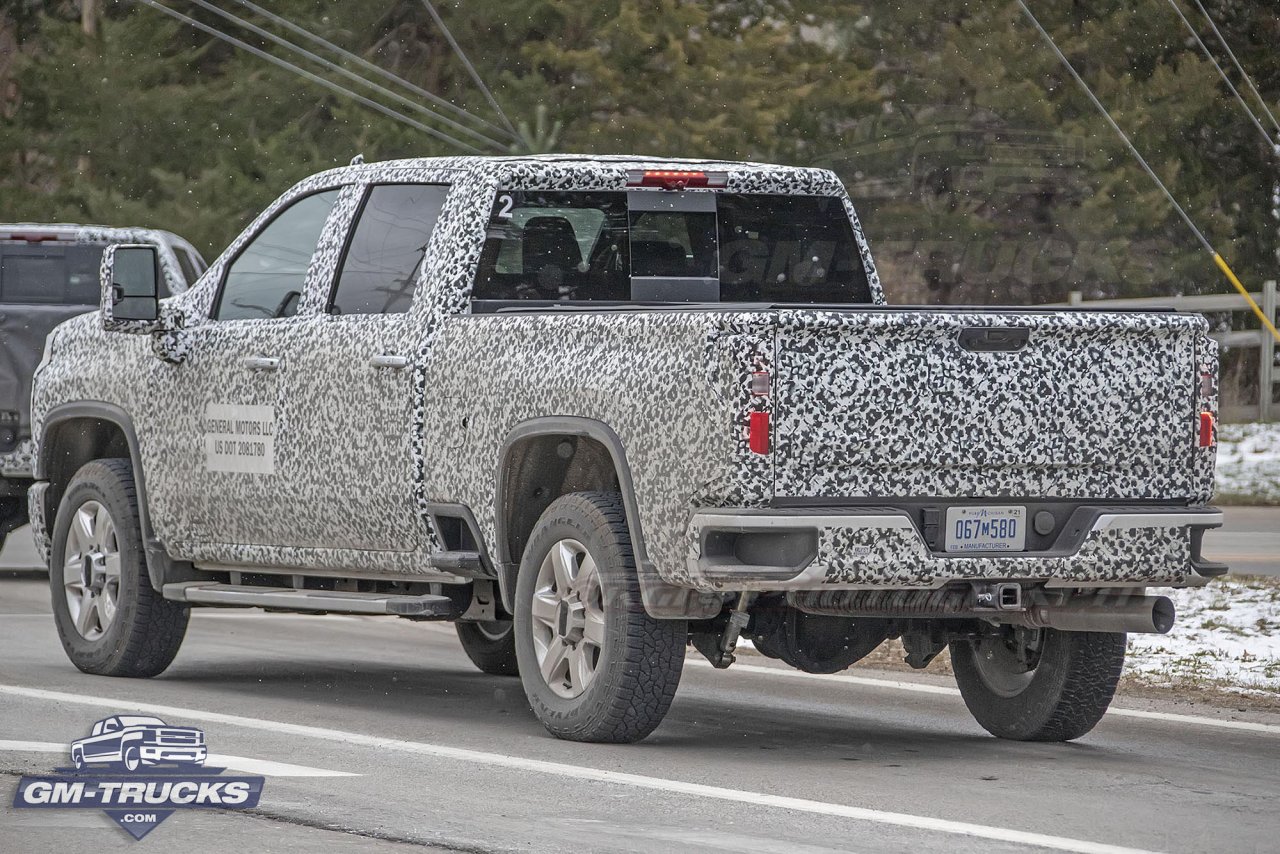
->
xmin=0 ymin=685 xmax=1151 ymax=854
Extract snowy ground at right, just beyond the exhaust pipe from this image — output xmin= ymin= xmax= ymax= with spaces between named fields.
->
xmin=1125 ymin=577 xmax=1280 ymax=699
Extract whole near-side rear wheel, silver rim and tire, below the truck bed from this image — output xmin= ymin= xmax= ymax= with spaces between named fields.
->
xmin=516 ymin=493 xmax=689 ymax=744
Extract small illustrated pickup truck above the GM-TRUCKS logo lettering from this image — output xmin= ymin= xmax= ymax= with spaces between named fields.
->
xmin=72 ymin=714 xmax=209 ymax=771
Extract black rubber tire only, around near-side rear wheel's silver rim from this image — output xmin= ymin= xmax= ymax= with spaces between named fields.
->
xmin=516 ymin=493 xmax=689 ymax=744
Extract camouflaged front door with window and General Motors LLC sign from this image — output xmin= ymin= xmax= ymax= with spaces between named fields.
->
xmin=147 ymin=189 xmax=340 ymax=550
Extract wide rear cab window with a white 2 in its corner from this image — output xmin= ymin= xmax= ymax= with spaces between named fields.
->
xmin=472 ymin=191 xmax=872 ymax=303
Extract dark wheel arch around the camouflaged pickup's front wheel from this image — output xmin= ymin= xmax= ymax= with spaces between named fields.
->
xmin=35 ymin=401 xmax=189 ymax=592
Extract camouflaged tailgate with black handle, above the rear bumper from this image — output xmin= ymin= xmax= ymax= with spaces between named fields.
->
xmin=773 ymin=310 xmax=1207 ymax=499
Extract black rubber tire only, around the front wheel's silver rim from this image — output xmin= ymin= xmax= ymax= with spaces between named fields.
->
xmin=49 ymin=460 xmax=191 ymax=677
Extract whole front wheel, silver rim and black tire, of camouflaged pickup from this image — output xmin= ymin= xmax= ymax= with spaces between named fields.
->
xmin=49 ymin=460 xmax=191 ymax=676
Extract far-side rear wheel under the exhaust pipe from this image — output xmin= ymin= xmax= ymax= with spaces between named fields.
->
xmin=951 ymin=626 xmax=1126 ymax=741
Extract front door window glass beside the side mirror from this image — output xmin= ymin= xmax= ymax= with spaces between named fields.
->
xmin=214 ymin=189 xmax=338 ymax=320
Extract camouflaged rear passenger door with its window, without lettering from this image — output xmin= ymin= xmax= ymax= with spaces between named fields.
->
xmin=279 ymin=183 xmax=449 ymax=552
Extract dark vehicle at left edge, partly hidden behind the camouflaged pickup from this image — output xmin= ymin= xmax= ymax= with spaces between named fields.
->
xmin=0 ymin=223 xmax=206 ymax=547
